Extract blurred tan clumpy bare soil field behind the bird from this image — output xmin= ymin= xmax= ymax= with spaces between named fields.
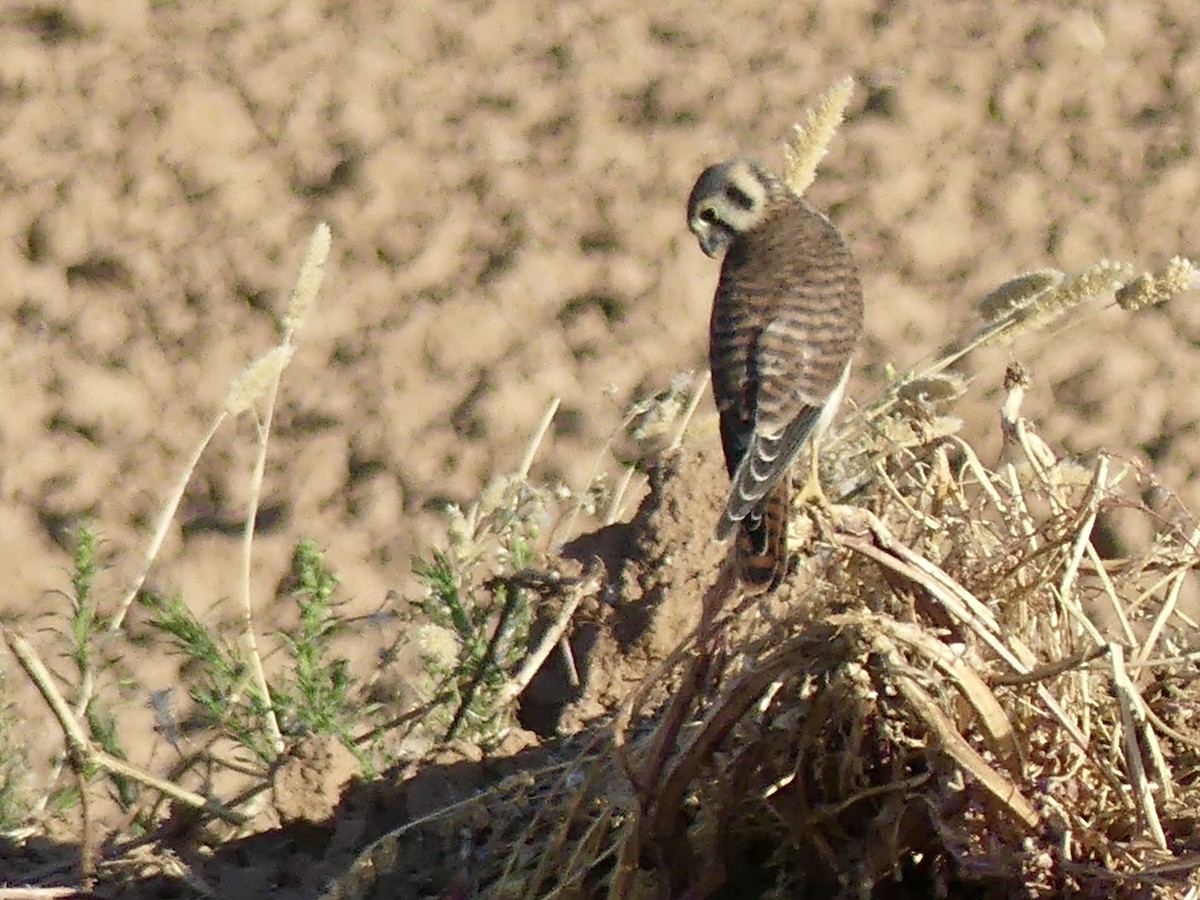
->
xmin=0 ymin=0 xmax=1200 ymax=897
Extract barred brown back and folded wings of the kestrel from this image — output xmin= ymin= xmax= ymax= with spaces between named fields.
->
xmin=710 ymin=200 xmax=863 ymax=539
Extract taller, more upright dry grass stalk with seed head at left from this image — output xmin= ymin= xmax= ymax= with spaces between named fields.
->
xmin=241 ymin=222 xmax=330 ymax=754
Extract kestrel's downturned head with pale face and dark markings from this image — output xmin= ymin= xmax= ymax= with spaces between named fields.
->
xmin=688 ymin=158 xmax=781 ymax=258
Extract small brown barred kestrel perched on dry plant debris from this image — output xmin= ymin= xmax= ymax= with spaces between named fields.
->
xmin=688 ymin=160 xmax=863 ymax=593
